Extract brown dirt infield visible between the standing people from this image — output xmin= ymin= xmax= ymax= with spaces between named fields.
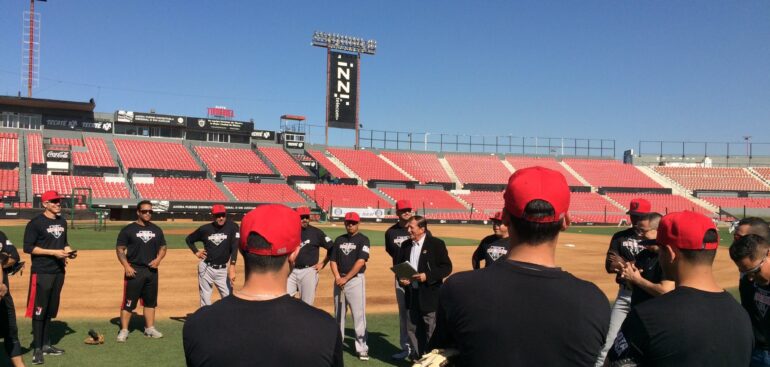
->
xmin=4 ymin=225 xmax=738 ymax=318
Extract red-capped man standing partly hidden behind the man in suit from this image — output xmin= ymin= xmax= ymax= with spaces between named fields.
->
xmin=385 ymin=199 xmax=415 ymax=359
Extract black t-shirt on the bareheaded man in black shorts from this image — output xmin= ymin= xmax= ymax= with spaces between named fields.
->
xmin=115 ymin=222 xmax=166 ymax=266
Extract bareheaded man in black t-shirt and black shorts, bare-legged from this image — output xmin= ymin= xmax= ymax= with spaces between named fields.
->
xmin=115 ymin=200 xmax=166 ymax=343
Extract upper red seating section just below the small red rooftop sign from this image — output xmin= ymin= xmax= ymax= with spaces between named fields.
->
xmin=195 ymin=146 xmax=274 ymax=175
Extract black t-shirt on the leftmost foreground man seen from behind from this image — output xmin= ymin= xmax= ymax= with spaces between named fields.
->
xmin=182 ymin=295 xmax=343 ymax=367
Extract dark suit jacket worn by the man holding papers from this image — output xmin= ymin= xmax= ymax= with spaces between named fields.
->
xmin=398 ymin=236 xmax=452 ymax=313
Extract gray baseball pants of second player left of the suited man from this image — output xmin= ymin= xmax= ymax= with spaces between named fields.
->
xmin=334 ymin=274 xmax=369 ymax=353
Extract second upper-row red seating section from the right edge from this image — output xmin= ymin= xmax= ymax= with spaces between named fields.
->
xmin=564 ymin=158 xmax=662 ymax=189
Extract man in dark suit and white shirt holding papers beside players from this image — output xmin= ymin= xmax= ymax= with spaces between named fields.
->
xmin=399 ymin=215 xmax=452 ymax=358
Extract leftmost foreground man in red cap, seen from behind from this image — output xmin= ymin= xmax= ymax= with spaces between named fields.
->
xmin=182 ymin=204 xmax=343 ymax=367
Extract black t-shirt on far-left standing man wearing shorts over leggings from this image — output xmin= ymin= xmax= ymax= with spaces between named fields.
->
xmin=24 ymin=214 xmax=67 ymax=274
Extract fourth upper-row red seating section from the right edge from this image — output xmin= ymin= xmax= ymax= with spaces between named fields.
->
xmin=444 ymin=154 xmax=511 ymax=184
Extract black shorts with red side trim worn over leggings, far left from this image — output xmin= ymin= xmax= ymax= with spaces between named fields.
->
xmin=24 ymin=273 xmax=64 ymax=320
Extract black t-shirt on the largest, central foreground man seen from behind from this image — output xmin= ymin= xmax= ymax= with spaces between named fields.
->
xmin=429 ymin=260 xmax=610 ymax=366
